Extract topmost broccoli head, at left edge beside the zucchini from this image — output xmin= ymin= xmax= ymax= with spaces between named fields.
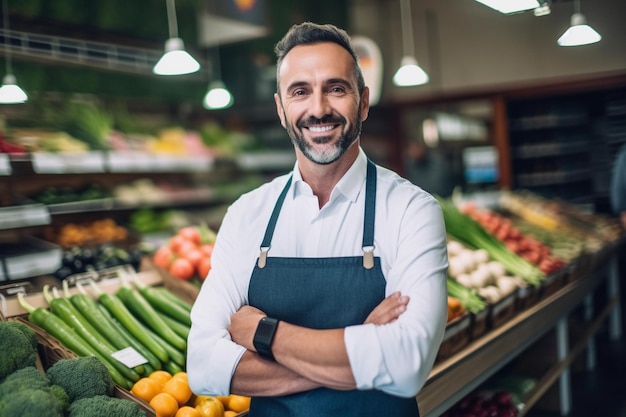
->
xmin=0 ymin=321 xmax=37 ymax=381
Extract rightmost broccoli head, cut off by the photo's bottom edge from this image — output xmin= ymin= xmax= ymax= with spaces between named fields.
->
xmin=68 ymin=395 xmax=147 ymax=417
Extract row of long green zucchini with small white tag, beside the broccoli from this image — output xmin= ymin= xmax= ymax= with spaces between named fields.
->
xmin=18 ymin=268 xmax=191 ymax=389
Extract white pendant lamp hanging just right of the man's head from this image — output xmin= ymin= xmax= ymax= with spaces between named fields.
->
xmin=393 ymin=0 xmax=428 ymax=87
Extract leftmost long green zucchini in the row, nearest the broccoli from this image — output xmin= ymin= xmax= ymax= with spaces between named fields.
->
xmin=17 ymin=293 xmax=132 ymax=389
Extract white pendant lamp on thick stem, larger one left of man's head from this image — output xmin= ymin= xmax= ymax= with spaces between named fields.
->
xmin=152 ymin=0 xmax=200 ymax=75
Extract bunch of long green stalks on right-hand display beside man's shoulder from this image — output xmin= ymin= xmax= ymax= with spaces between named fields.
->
xmin=439 ymin=199 xmax=545 ymax=286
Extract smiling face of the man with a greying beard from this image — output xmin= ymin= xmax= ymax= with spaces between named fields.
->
xmin=274 ymin=42 xmax=369 ymax=164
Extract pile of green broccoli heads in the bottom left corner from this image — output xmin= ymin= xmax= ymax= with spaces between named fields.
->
xmin=0 ymin=321 xmax=146 ymax=417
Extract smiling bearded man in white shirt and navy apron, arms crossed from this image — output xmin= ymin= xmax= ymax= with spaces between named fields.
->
xmin=187 ymin=23 xmax=447 ymax=417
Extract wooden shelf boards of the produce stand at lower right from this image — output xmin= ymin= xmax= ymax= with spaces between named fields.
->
xmin=417 ymin=255 xmax=618 ymax=417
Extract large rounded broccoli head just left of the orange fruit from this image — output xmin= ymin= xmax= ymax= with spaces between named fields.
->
xmin=46 ymin=356 xmax=115 ymax=402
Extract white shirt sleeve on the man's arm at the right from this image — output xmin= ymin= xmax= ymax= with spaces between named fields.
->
xmin=344 ymin=189 xmax=447 ymax=397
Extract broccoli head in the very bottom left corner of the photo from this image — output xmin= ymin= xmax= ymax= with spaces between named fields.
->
xmin=0 ymin=388 xmax=64 ymax=417
